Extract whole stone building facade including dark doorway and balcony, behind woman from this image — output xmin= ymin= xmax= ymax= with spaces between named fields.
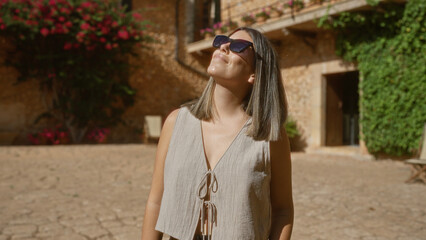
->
xmin=0 ymin=0 xmax=368 ymax=155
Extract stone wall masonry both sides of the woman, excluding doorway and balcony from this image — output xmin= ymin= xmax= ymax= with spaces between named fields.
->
xmin=0 ymin=0 xmax=352 ymax=149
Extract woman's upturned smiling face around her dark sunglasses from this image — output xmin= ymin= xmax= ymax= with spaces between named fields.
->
xmin=207 ymin=30 xmax=254 ymax=84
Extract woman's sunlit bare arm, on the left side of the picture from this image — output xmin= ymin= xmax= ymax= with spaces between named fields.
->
xmin=142 ymin=110 xmax=179 ymax=240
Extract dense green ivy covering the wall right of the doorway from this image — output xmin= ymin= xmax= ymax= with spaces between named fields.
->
xmin=318 ymin=0 xmax=426 ymax=156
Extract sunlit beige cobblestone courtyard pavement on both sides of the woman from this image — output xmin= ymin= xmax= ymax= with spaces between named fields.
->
xmin=0 ymin=145 xmax=426 ymax=240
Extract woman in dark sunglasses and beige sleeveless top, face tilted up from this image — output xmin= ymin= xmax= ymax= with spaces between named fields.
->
xmin=142 ymin=28 xmax=293 ymax=240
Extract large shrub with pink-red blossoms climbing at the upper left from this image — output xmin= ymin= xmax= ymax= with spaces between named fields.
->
xmin=0 ymin=0 xmax=151 ymax=142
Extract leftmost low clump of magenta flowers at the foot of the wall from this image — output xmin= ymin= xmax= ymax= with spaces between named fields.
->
xmin=28 ymin=125 xmax=69 ymax=145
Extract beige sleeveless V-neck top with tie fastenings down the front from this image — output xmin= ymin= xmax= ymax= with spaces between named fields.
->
xmin=155 ymin=107 xmax=271 ymax=240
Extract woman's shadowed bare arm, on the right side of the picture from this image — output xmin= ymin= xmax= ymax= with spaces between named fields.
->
xmin=269 ymin=129 xmax=294 ymax=240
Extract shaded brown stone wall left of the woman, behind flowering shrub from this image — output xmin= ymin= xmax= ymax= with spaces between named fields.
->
xmin=0 ymin=0 xmax=207 ymax=145
